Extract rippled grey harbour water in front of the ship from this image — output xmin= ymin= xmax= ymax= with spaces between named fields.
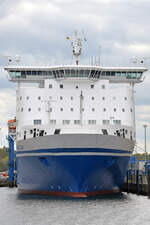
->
xmin=0 ymin=187 xmax=150 ymax=225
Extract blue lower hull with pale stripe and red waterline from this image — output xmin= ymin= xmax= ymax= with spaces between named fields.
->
xmin=17 ymin=148 xmax=130 ymax=197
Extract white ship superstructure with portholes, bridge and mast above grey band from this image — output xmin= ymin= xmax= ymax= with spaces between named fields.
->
xmin=5 ymin=32 xmax=147 ymax=146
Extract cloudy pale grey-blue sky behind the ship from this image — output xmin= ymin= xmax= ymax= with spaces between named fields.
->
xmin=0 ymin=0 xmax=150 ymax=153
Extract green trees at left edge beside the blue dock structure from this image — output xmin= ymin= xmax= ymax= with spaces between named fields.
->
xmin=0 ymin=147 xmax=8 ymax=172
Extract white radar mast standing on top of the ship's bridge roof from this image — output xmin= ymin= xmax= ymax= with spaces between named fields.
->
xmin=66 ymin=31 xmax=86 ymax=65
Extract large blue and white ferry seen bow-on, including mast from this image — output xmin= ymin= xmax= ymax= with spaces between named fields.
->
xmin=5 ymin=33 xmax=147 ymax=197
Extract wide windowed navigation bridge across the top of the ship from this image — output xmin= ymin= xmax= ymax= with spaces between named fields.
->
xmin=5 ymin=65 xmax=147 ymax=83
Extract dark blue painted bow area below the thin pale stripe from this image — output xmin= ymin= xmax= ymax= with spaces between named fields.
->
xmin=17 ymin=149 xmax=130 ymax=192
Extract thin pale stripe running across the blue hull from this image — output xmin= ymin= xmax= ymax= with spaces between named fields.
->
xmin=17 ymin=152 xmax=131 ymax=157
